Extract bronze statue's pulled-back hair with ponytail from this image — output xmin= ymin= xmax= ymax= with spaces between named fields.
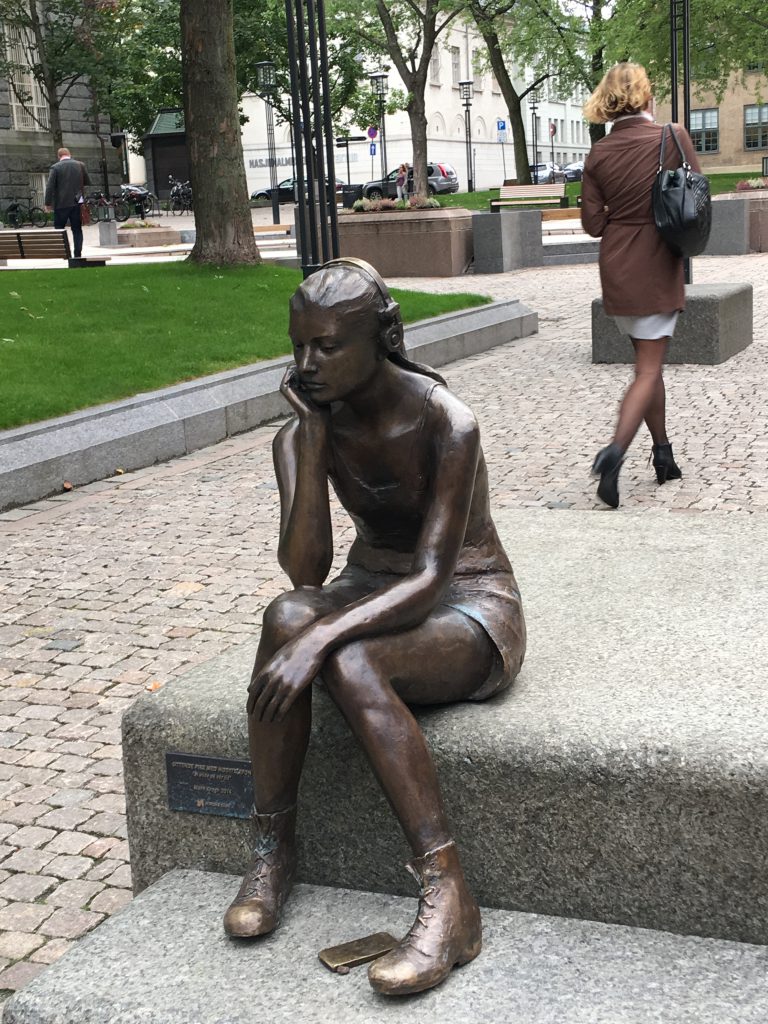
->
xmin=290 ymin=256 xmax=445 ymax=384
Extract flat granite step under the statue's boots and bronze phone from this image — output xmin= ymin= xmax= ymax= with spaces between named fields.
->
xmin=3 ymin=871 xmax=768 ymax=1024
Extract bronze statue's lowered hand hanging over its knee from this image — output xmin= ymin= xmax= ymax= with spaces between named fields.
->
xmin=247 ymin=631 xmax=324 ymax=722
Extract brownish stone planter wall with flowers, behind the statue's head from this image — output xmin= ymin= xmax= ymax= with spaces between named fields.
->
xmin=339 ymin=210 xmax=473 ymax=278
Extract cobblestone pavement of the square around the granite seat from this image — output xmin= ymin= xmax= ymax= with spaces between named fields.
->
xmin=0 ymin=255 xmax=768 ymax=998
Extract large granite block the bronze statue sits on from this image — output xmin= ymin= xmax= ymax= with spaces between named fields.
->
xmin=123 ymin=509 xmax=768 ymax=942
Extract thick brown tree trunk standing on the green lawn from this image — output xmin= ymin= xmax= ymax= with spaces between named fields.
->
xmin=181 ymin=0 xmax=261 ymax=264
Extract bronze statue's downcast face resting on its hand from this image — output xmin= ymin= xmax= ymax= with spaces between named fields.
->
xmin=289 ymin=303 xmax=381 ymax=406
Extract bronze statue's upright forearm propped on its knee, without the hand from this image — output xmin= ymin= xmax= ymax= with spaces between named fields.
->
xmin=272 ymin=419 xmax=333 ymax=587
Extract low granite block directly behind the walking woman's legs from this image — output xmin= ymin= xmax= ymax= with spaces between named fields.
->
xmin=592 ymin=284 xmax=753 ymax=366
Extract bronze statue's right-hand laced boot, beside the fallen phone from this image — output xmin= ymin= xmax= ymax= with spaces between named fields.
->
xmin=368 ymin=841 xmax=482 ymax=995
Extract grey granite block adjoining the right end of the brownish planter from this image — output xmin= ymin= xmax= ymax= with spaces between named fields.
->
xmin=472 ymin=210 xmax=544 ymax=273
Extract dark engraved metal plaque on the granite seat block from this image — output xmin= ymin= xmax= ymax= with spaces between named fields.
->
xmin=165 ymin=752 xmax=253 ymax=818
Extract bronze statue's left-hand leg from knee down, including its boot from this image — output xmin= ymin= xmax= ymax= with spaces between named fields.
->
xmin=224 ymin=587 xmax=342 ymax=938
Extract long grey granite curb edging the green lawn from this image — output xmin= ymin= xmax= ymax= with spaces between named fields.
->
xmin=0 ymin=299 xmax=539 ymax=511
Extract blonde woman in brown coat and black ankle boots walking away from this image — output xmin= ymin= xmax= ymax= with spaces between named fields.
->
xmin=582 ymin=63 xmax=699 ymax=508
